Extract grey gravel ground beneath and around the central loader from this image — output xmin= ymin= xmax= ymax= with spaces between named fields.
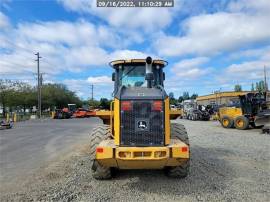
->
xmin=1 ymin=120 xmax=270 ymax=202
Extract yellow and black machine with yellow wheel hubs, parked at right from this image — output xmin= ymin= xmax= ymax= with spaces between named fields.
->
xmin=218 ymin=93 xmax=267 ymax=130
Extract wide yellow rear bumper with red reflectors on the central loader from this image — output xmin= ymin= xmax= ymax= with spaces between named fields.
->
xmin=96 ymin=139 xmax=189 ymax=169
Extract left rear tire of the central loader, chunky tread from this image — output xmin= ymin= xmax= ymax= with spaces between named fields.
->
xmin=90 ymin=125 xmax=112 ymax=180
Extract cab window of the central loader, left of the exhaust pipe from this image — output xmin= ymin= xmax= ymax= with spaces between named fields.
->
xmin=119 ymin=65 xmax=146 ymax=87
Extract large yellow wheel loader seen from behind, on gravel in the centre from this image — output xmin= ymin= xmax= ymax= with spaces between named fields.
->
xmin=90 ymin=57 xmax=190 ymax=179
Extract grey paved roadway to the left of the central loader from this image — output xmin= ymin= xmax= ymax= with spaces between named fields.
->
xmin=0 ymin=118 xmax=101 ymax=184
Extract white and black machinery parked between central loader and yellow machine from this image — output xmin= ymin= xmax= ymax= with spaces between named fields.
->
xmin=183 ymin=100 xmax=210 ymax=121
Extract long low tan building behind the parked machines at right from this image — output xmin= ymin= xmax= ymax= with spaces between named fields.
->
xmin=196 ymin=91 xmax=251 ymax=106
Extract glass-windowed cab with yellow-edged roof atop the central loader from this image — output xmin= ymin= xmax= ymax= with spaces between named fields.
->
xmin=110 ymin=58 xmax=167 ymax=94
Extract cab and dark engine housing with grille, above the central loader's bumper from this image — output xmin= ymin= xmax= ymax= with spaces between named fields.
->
xmin=111 ymin=57 xmax=169 ymax=146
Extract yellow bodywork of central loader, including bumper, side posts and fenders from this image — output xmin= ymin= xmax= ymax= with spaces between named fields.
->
xmin=96 ymin=98 xmax=190 ymax=169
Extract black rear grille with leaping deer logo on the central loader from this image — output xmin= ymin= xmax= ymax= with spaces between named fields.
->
xmin=120 ymin=101 xmax=164 ymax=146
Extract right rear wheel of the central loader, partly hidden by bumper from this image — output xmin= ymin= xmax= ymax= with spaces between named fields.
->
xmin=165 ymin=123 xmax=190 ymax=178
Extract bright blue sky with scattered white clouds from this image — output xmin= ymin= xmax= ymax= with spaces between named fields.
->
xmin=0 ymin=0 xmax=270 ymax=99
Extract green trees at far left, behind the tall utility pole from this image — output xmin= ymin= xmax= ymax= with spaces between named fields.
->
xmin=0 ymin=79 xmax=82 ymax=116
